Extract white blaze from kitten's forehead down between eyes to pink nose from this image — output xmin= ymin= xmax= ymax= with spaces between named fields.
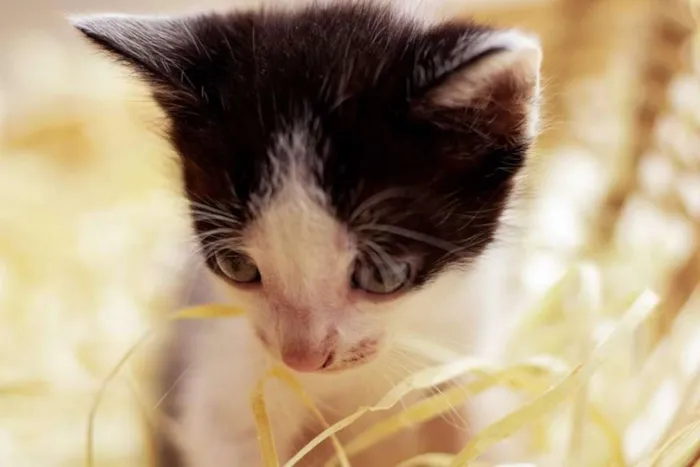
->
xmin=245 ymin=125 xmax=354 ymax=354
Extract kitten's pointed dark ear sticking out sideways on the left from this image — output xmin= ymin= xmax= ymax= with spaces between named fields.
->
xmin=70 ymin=15 xmax=199 ymax=90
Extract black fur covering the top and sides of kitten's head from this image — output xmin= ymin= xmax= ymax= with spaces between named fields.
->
xmin=77 ymin=4 xmax=530 ymax=285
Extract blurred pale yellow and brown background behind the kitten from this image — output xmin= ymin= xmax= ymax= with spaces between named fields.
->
xmin=0 ymin=0 xmax=700 ymax=467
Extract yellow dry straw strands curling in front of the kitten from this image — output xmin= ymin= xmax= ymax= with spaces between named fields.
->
xmin=79 ymin=275 xmax=700 ymax=467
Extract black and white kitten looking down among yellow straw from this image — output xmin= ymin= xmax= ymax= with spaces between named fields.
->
xmin=75 ymin=2 xmax=541 ymax=467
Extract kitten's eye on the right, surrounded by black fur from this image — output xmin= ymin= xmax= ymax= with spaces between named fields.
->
xmin=352 ymin=260 xmax=412 ymax=294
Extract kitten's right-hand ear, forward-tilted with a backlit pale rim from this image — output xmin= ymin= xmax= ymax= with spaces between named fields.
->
xmin=414 ymin=30 xmax=542 ymax=139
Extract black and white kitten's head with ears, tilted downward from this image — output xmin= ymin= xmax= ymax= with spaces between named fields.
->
xmin=75 ymin=4 xmax=541 ymax=371
